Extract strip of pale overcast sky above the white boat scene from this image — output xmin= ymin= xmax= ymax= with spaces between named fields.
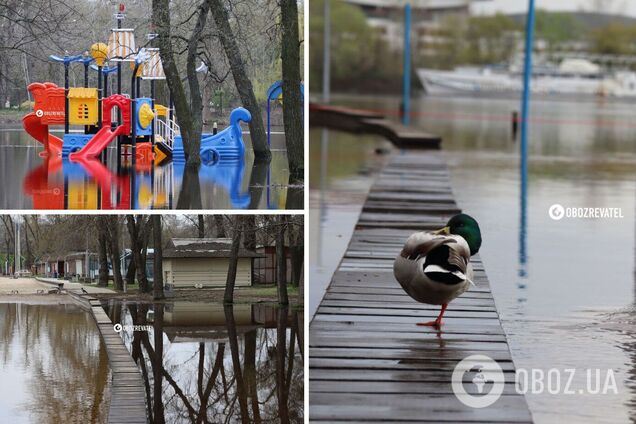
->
xmin=472 ymin=0 xmax=636 ymax=17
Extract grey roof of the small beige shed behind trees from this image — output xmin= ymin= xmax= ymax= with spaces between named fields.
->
xmin=163 ymin=238 xmax=264 ymax=258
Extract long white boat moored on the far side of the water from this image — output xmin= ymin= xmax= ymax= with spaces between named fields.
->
xmin=417 ymin=59 xmax=636 ymax=99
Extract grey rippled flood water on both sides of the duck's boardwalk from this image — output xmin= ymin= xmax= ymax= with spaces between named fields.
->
xmin=310 ymin=97 xmax=636 ymax=423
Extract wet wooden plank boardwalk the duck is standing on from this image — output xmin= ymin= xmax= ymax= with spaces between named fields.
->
xmin=309 ymin=150 xmax=532 ymax=423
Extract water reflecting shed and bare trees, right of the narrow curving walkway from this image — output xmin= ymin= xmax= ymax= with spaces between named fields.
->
xmin=105 ymin=301 xmax=304 ymax=423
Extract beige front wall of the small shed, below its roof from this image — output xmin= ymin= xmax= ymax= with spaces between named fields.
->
xmin=163 ymin=258 xmax=252 ymax=288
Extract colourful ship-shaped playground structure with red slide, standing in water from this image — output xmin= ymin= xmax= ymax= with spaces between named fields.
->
xmin=22 ymin=5 xmax=251 ymax=168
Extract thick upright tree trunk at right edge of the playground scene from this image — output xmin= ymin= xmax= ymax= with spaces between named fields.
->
xmin=280 ymin=0 xmax=304 ymax=182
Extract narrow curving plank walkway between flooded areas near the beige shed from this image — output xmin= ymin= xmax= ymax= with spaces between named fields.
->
xmin=67 ymin=291 xmax=148 ymax=424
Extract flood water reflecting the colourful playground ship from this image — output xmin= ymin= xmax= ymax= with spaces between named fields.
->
xmin=0 ymin=125 xmax=303 ymax=209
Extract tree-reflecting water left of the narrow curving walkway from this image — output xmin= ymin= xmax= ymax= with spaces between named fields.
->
xmin=0 ymin=303 xmax=110 ymax=424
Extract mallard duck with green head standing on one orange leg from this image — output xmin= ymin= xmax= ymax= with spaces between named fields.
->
xmin=393 ymin=214 xmax=481 ymax=328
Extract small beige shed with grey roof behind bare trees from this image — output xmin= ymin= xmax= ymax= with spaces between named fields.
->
xmin=162 ymin=238 xmax=262 ymax=288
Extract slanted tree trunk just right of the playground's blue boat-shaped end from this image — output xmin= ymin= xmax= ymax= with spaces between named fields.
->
xmin=207 ymin=0 xmax=272 ymax=160
